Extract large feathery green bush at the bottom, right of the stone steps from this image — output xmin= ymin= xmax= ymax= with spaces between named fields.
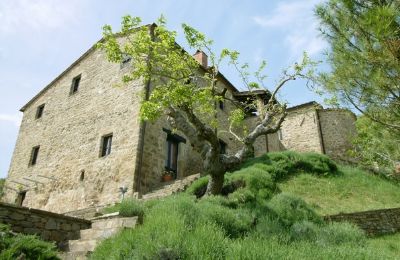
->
xmin=91 ymin=195 xmax=227 ymax=259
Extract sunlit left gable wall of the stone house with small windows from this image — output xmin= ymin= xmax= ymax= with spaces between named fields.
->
xmin=3 ymin=43 xmax=143 ymax=212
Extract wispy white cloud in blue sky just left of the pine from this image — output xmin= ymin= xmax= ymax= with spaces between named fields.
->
xmin=253 ymin=0 xmax=327 ymax=60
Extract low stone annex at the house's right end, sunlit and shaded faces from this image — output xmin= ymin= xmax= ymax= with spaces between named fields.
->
xmin=276 ymin=102 xmax=356 ymax=161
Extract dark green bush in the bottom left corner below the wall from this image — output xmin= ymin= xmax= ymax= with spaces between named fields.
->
xmin=0 ymin=224 xmax=59 ymax=260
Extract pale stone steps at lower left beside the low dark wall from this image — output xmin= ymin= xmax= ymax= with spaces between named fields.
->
xmin=60 ymin=214 xmax=138 ymax=260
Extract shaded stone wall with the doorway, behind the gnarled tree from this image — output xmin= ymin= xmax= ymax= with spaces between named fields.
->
xmin=140 ymin=82 xmax=274 ymax=193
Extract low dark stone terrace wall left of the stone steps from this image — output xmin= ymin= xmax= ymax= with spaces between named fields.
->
xmin=0 ymin=203 xmax=91 ymax=248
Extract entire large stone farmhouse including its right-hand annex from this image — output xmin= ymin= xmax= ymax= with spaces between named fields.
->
xmin=3 ymin=36 xmax=355 ymax=213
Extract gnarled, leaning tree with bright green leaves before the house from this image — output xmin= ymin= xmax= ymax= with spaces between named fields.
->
xmin=99 ymin=16 xmax=313 ymax=194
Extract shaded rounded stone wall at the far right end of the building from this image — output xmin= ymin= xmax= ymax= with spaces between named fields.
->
xmin=317 ymin=109 xmax=356 ymax=160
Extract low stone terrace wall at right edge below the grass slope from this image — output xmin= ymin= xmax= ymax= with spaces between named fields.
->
xmin=325 ymin=208 xmax=400 ymax=236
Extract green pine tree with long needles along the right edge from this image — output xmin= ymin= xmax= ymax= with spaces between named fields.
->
xmin=316 ymin=0 xmax=400 ymax=172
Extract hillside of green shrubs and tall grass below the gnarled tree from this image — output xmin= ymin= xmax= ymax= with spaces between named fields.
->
xmin=91 ymin=152 xmax=398 ymax=259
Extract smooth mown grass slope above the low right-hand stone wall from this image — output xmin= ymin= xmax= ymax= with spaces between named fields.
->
xmin=279 ymin=167 xmax=400 ymax=215
